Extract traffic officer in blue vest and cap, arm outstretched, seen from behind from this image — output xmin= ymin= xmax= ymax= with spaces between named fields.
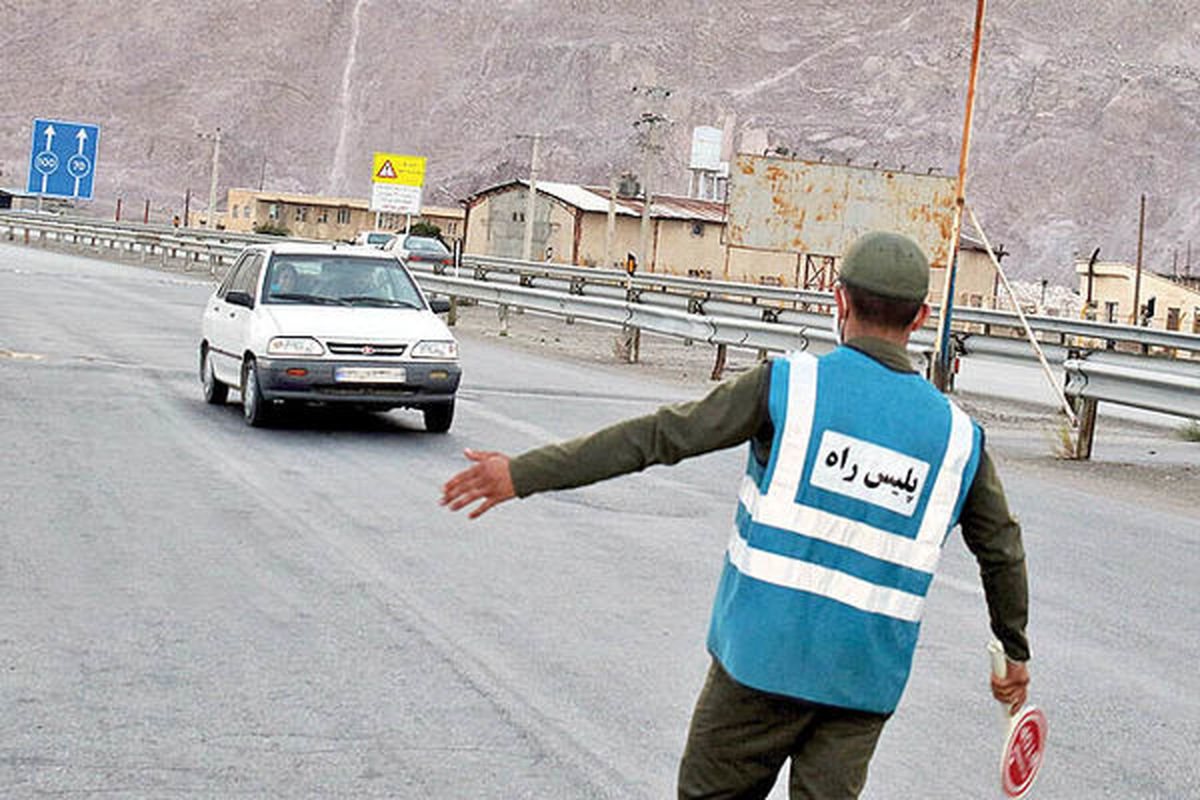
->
xmin=442 ymin=233 xmax=1030 ymax=800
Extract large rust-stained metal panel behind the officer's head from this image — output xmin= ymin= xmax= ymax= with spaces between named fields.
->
xmin=727 ymin=155 xmax=955 ymax=267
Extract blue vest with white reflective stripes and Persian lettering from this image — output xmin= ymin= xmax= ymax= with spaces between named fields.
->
xmin=708 ymin=347 xmax=982 ymax=714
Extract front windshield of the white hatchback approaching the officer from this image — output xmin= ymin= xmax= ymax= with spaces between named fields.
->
xmin=263 ymin=253 xmax=425 ymax=308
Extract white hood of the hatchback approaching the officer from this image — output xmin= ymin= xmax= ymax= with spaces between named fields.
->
xmin=262 ymin=303 xmax=454 ymax=342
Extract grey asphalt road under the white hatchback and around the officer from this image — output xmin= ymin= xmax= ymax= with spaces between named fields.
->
xmin=0 ymin=245 xmax=1200 ymax=800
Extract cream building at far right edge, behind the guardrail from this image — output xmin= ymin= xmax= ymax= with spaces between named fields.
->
xmin=1075 ymin=259 xmax=1200 ymax=333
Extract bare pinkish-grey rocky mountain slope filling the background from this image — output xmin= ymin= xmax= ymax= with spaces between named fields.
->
xmin=0 ymin=0 xmax=1200 ymax=282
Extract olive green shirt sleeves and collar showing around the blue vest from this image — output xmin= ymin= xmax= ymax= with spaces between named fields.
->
xmin=510 ymin=337 xmax=1030 ymax=661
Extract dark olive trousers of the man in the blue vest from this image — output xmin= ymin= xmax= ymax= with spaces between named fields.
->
xmin=678 ymin=660 xmax=890 ymax=800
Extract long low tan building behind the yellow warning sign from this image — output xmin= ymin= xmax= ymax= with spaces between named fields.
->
xmin=212 ymin=188 xmax=464 ymax=242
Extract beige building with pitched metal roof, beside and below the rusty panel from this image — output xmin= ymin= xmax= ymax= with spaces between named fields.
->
xmin=463 ymin=180 xmax=997 ymax=307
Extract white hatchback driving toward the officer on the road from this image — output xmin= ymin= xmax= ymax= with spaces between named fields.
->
xmin=199 ymin=242 xmax=462 ymax=433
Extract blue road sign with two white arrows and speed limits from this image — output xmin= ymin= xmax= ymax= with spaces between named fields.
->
xmin=26 ymin=120 xmax=100 ymax=200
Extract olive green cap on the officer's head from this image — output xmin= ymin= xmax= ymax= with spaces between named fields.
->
xmin=840 ymin=231 xmax=929 ymax=301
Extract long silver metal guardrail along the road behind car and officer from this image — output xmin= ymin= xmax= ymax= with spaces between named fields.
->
xmin=0 ymin=212 xmax=1200 ymax=458
